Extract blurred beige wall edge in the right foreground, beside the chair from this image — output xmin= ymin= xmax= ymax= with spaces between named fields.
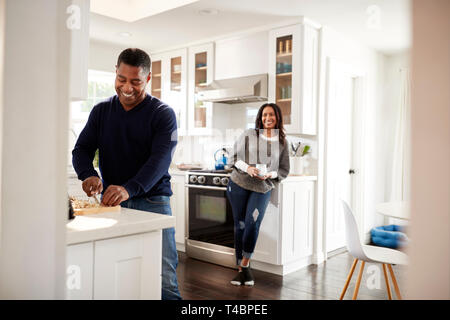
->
xmin=406 ymin=0 xmax=450 ymax=299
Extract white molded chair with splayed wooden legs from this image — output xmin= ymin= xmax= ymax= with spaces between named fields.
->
xmin=339 ymin=200 xmax=408 ymax=300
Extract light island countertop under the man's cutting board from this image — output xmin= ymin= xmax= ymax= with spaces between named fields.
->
xmin=66 ymin=208 xmax=175 ymax=245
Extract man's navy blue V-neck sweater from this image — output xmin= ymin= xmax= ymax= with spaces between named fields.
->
xmin=72 ymin=95 xmax=177 ymax=198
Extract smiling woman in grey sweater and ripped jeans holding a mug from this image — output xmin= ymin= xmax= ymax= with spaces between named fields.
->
xmin=227 ymin=103 xmax=289 ymax=286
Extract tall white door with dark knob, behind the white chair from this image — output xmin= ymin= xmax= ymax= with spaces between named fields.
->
xmin=324 ymin=58 xmax=363 ymax=255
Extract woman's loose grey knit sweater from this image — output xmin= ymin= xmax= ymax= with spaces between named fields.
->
xmin=230 ymin=129 xmax=289 ymax=193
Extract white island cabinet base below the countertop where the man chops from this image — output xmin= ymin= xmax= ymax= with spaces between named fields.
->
xmin=67 ymin=231 xmax=162 ymax=300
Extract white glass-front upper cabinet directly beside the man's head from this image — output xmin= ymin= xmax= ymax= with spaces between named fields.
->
xmin=150 ymin=49 xmax=187 ymax=135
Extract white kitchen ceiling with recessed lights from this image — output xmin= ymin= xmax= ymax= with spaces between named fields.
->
xmin=90 ymin=0 xmax=411 ymax=54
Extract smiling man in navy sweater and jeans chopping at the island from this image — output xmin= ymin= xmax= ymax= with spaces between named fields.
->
xmin=72 ymin=49 xmax=181 ymax=300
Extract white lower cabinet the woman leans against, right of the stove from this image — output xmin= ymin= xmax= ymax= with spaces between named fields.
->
xmin=253 ymin=178 xmax=315 ymax=274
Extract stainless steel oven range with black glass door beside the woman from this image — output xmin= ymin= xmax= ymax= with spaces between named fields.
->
xmin=185 ymin=170 xmax=236 ymax=268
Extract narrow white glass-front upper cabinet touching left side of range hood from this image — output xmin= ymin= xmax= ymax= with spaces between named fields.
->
xmin=188 ymin=43 xmax=214 ymax=135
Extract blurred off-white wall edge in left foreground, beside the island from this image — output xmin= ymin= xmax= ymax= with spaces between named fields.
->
xmin=0 ymin=0 xmax=71 ymax=299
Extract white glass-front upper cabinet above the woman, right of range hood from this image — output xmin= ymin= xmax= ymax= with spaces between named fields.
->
xmin=269 ymin=23 xmax=319 ymax=135
